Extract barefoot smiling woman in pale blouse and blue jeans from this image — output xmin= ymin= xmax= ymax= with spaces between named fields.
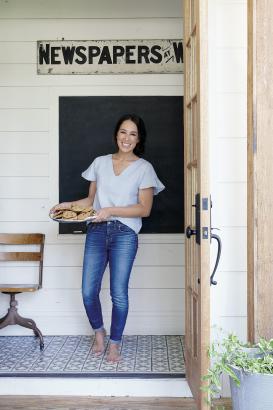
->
xmin=55 ymin=115 xmax=165 ymax=362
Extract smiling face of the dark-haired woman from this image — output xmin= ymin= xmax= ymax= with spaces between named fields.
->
xmin=117 ymin=120 xmax=139 ymax=153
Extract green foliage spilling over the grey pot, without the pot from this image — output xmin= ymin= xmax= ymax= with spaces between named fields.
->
xmin=201 ymin=334 xmax=273 ymax=404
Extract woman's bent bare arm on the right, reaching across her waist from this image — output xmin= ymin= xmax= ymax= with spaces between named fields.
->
xmin=94 ymin=188 xmax=154 ymax=222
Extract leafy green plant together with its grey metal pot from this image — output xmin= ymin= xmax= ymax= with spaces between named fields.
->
xmin=202 ymin=334 xmax=273 ymax=410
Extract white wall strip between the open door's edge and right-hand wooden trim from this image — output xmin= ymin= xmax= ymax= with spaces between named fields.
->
xmin=208 ymin=0 xmax=247 ymax=340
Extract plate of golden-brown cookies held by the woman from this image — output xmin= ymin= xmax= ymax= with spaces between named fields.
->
xmin=49 ymin=205 xmax=96 ymax=222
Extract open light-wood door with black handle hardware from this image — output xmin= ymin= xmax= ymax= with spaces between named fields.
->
xmin=184 ymin=0 xmax=210 ymax=409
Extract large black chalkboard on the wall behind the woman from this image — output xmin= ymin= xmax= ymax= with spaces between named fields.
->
xmin=59 ymin=96 xmax=184 ymax=233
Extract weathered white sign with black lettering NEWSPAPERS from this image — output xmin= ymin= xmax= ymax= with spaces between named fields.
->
xmin=37 ymin=40 xmax=183 ymax=74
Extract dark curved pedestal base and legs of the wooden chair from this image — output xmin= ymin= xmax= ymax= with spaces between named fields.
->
xmin=0 ymin=293 xmax=44 ymax=350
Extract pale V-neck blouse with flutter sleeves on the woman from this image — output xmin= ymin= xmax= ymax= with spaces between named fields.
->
xmin=82 ymin=154 xmax=165 ymax=233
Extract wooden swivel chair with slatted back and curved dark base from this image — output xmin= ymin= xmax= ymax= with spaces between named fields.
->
xmin=0 ymin=233 xmax=45 ymax=350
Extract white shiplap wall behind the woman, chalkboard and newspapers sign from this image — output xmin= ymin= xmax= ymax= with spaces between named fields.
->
xmin=0 ymin=0 xmax=184 ymax=335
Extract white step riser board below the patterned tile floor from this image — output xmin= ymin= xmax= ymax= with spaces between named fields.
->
xmin=0 ymin=377 xmax=192 ymax=397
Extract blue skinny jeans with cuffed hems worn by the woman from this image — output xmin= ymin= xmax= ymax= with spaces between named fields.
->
xmin=82 ymin=220 xmax=138 ymax=343
